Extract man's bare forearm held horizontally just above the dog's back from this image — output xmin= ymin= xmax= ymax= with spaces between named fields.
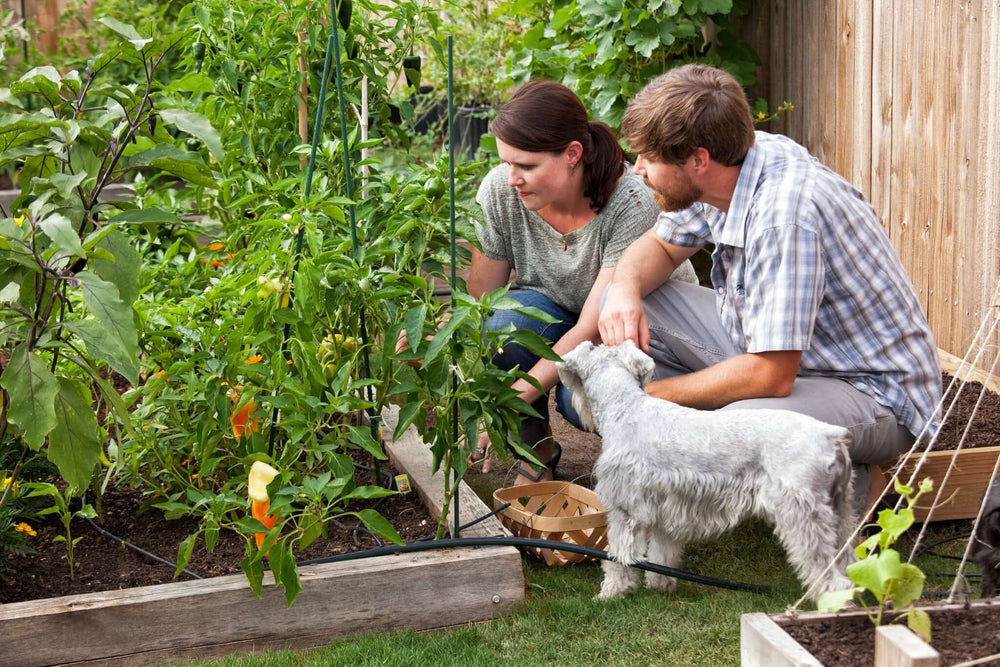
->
xmin=646 ymin=350 xmax=802 ymax=410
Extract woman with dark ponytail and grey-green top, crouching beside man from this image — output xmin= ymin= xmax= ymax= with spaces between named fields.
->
xmin=468 ymin=81 xmax=695 ymax=483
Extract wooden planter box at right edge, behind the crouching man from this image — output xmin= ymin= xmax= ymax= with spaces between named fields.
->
xmin=900 ymin=350 xmax=1000 ymax=521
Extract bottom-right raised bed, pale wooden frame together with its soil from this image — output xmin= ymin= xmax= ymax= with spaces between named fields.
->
xmin=740 ymin=600 xmax=1000 ymax=667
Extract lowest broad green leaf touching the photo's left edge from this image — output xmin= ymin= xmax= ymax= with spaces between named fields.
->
xmin=0 ymin=343 xmax=59 ymax=451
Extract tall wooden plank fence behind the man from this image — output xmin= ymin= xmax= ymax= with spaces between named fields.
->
xmin=744 ymin=0 xmax=1000 ymax=369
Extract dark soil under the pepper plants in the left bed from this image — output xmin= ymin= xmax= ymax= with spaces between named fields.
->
xmin=0 ymin=465 xmax=436 ymax=603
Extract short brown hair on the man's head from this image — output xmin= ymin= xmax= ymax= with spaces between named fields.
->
xmin=622 ymin=65 xmax=754 ymax=167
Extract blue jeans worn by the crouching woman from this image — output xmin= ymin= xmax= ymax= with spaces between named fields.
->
xmin=486 ymin=290 xmax=581 ymax=447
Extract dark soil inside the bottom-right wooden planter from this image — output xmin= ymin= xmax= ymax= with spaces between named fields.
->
xmin=782 ymin=604 xmax=1000 ymax=667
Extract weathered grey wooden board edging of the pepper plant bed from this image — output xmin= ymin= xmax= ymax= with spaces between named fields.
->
xmin=0 ymin=404 xmax=524 ymax=667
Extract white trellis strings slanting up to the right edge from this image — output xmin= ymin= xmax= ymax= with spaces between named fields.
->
xmin=785 ymin=281 xmax=1000 ymax=615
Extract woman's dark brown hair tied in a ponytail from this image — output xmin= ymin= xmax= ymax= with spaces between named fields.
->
xmin=490 ymin=81 xmax=625 ymax=211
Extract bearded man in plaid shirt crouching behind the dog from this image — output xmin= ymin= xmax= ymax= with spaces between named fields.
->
xmin=599 ymin=65 xmax=941 ymax=512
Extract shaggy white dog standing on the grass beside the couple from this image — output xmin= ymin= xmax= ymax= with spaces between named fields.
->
xmin=556 ymin=341 xmax=853 ymax=599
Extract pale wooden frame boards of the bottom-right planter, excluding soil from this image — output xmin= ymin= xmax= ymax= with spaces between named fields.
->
xmin=740 ymin=600 xmax=996 ymax=667
